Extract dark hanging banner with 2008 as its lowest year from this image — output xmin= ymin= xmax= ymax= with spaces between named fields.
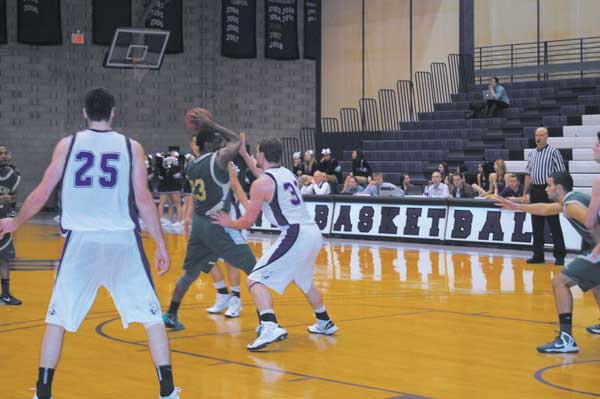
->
xmin=265 ymin=0 xmax=300 ymax=60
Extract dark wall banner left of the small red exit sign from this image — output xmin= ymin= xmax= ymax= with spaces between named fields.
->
xmin=17 ymin=0 xmax=62 ymax=45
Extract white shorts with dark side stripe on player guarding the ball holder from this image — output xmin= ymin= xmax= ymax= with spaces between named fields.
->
xmin=248 ymin=224 xmax=323 ymax=295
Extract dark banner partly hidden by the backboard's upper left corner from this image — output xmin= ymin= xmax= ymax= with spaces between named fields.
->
xmin=92 ymin=0 xmax=131 ymax=46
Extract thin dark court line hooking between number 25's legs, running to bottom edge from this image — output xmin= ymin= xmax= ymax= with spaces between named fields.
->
xmin=96 ymin=317 xmax=430 ymax=399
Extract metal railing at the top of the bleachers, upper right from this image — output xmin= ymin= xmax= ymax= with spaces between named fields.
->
xmin=474 ymin=36 xmax=600 ymax=83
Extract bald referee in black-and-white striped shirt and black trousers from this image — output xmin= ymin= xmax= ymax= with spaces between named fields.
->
xmin=523 ymin=127 xmax=567 ymax=266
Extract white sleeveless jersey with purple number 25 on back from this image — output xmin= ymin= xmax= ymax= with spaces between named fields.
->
xmin=60 ymin=130 xmax=137 ymax=231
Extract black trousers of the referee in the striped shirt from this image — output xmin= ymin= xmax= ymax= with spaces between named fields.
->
xmin=529 ymin=184 xmax=567 ymax=259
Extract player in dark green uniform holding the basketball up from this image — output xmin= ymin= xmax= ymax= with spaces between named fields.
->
xmin=163 ymin=108 xmax=256 ymax=330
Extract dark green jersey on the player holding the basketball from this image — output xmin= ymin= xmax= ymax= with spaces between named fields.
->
xmin=186 ymin=152 xmax=230 ymax=215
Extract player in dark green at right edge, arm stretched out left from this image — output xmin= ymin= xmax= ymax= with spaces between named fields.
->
xmin=497 ymin=172 xmax=600 ymax=353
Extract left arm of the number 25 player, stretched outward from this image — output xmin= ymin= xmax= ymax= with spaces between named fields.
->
xmin=0 ymin=137 xmax=72 ymax=236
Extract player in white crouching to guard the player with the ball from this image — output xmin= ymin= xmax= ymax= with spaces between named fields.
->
xmin=214 ymin=138 xmax=338 ymax=351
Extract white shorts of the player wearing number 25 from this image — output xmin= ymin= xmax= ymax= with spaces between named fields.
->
xmin=46 ymin=230 xmax=162 ymax=332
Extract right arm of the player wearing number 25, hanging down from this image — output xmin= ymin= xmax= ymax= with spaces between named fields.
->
xmin=131 ymin=140 xmax=170 ymax=276
